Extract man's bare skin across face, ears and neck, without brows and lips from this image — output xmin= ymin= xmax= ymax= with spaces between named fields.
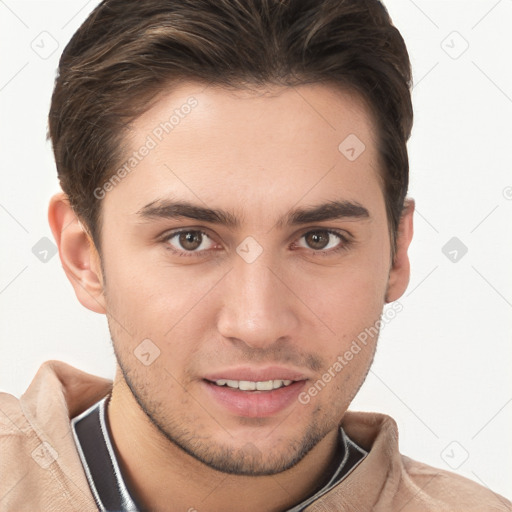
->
xmin=49 ymin=82 xmax=414 ymax=512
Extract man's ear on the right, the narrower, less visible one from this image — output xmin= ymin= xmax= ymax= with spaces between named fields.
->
xmin=386 ymin=199 xmax=414 ymax=302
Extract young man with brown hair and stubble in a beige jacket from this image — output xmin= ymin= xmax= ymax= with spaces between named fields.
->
xmin=0 ymin=0 xmax=512 ymax=512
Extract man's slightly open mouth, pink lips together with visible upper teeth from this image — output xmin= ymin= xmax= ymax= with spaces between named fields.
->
xmin=202 ymin=370 xmax=308 ymax=418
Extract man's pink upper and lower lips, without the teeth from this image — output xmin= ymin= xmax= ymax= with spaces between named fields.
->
xmin=202 ymin=366 xmax=308 ymax=418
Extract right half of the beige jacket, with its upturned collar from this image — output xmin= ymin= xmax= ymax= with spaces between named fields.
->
xmin=332 ymin=411 xmax=512 ymax=512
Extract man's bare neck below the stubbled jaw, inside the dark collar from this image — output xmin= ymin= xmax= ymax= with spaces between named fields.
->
xmin=107 ymin=373 xmax=339 ymax=512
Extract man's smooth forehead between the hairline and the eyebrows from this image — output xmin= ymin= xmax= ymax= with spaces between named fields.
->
xmin=106 ymin=82 xmax=382 ymax=224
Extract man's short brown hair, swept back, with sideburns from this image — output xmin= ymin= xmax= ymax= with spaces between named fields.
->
xmin=48 ymin=0 xmax=413 ymax=252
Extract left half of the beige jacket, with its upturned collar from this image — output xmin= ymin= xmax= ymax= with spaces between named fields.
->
xmin=0 ymin=361 xmax=111 ymax=511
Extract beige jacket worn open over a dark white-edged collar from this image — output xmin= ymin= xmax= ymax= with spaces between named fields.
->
xmin=0 ymin=361 xmax=512 ymax=512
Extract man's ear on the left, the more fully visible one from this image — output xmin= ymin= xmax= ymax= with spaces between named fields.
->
xmin=48 ymin=192 xmax=106 ymax=313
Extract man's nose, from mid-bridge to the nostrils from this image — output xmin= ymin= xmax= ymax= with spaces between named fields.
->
xmin=217 ymin=251 xmax=299 ymax=348
